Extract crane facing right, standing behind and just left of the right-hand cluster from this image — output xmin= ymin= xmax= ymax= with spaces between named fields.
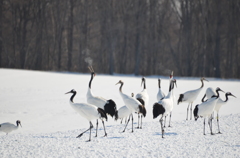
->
xmin=178 ymin=77 xmax=208 ymax=120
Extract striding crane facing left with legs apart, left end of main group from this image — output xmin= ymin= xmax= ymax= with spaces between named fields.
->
xmin=65 ymin=89 xmax=107 ymax=141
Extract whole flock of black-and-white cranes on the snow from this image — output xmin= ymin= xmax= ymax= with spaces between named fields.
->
xmin=0 ymin=67 xmax=235 ymax=141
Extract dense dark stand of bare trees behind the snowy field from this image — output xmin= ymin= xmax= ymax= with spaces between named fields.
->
xmin=0 ymin=0 xmax=240 ymax=78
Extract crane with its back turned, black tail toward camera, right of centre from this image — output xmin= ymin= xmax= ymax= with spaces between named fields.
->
xmin=153 ymin=79 xmax=176 ymax=138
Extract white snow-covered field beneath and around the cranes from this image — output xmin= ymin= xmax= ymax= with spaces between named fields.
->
xmin=0 ymin=69 xmax=240 ymax=157
